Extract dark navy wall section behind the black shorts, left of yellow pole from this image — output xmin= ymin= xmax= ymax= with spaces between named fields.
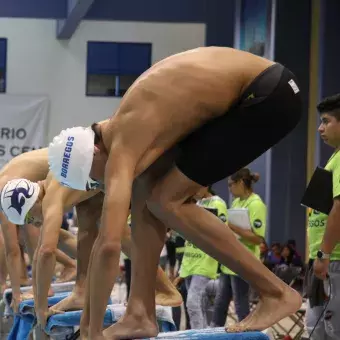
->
xmin=269 ymin=0 xmax=311 ymax=253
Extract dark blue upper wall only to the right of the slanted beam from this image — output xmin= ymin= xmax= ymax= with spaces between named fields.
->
xmin=85 ymin=0 xmax=235 ymax=47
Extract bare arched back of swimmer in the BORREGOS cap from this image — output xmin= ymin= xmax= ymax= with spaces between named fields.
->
xmin=101 ymin=47 xmax=274 ymax=177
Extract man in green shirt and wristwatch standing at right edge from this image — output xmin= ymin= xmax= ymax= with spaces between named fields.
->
xmin=306 ymin=94 xmax=340 ymax=340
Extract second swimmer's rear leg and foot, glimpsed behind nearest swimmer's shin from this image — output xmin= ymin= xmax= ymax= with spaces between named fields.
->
xmin=122 ymin=220 xmax=183 ymax=307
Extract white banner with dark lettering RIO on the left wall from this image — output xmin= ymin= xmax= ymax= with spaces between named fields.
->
xmin=0 ymin=95 xmax=49 ymax=169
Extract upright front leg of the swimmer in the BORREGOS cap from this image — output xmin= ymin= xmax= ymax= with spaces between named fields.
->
xmin=103 ymin=180 xmax=166 ymax=340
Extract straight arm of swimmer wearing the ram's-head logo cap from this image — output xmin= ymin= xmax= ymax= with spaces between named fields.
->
xmin=35 ymin=193 xmax=63 ymax=311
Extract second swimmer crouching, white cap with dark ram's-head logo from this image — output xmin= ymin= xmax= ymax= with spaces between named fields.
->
xmin=1 ymin=174 xmax=182 ymax=326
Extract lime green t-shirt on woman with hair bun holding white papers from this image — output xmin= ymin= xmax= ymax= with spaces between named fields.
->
xmin=221 ymin=194 xmax=267 ymax=275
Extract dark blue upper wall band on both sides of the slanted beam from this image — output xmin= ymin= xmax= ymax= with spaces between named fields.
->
xmin=0 ymin=0 xmax=235 ymax=46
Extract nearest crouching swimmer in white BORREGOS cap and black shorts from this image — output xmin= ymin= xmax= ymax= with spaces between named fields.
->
xmin=49 ymin=47 xmax=301 ymax=340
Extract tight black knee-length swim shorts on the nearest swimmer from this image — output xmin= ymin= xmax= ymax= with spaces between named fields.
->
xmin=176 ymin=64 xmax=302 ymax=186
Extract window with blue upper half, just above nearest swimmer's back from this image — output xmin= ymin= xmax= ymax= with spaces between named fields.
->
xmin=86 ymin=41 xmax=152 ymax=97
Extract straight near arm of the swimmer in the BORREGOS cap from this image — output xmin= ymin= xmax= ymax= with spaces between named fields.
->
xmin=86 ymin=150 xmax=135 ymax=327
